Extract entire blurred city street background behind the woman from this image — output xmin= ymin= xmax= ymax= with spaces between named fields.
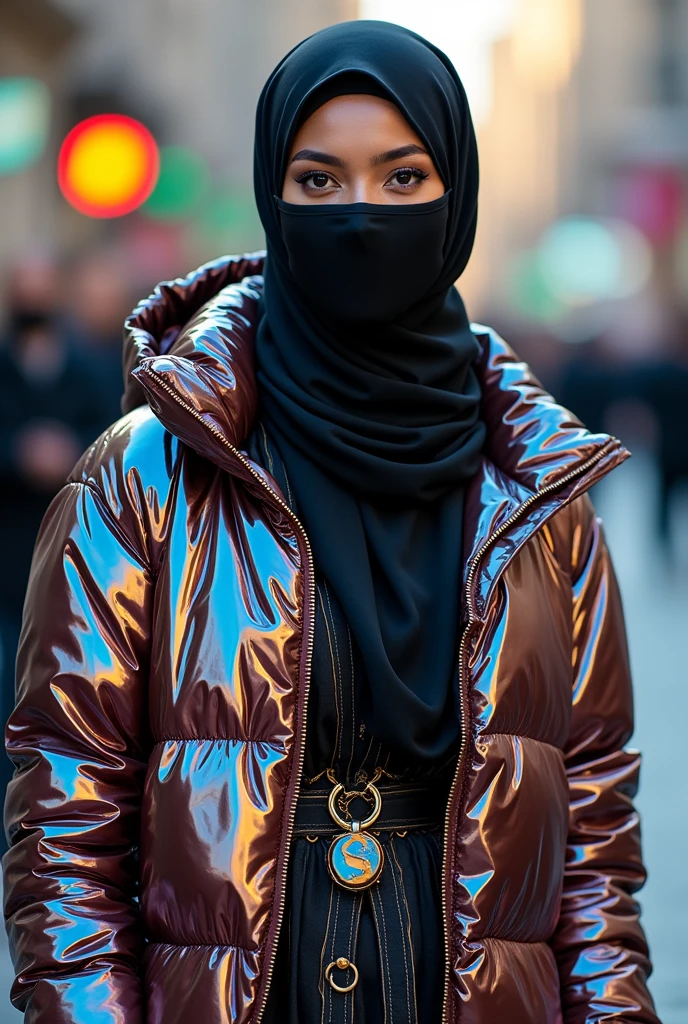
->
xmin=0 ymin=0 xmax=688 ymax=1024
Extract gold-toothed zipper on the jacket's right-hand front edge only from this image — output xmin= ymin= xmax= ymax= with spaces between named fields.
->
xmin=441 ymin=437 xmax=618 ymax=1024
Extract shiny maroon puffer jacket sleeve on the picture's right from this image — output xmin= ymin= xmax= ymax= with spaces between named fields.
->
xmin=553 ymin=497 xmax=657 ymax=1024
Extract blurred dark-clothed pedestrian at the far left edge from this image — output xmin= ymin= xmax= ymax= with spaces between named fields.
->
xmin=0 ymin=255 xmax=100 ymax=851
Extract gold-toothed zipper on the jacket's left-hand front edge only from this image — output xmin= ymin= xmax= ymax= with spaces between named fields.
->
xmin=143 ymin=367 xmax=315 ymax=1024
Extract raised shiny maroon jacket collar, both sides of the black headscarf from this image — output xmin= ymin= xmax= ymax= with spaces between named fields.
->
xmin=123 ymin=253 xmax=628 ymax=544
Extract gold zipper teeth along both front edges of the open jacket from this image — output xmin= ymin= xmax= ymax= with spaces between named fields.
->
xmin=143 ymin=368 xmax=619 ymax=1024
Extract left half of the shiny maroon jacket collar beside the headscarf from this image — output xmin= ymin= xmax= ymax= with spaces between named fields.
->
xmin=122 ymin=253 xmax=264 ymax=478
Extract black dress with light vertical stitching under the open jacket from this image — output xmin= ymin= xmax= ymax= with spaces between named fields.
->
xmin=247 ymin=424 xmax=456 ymax=1024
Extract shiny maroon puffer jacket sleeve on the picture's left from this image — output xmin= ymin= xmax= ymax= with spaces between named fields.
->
xmin=3 ymin=482 xmax=153 ymax=1024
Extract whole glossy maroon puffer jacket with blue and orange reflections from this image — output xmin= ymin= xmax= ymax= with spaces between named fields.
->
xmin=4 ymin=256 xmax=657 ymax=1024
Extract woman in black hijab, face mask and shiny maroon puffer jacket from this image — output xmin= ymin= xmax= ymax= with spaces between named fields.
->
xmin=5 ymin=23 xmax=656 ymax=1024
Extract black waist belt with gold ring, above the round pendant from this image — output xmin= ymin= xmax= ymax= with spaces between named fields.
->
xmin=294 ymin=783 xmax=446 ymax=836
